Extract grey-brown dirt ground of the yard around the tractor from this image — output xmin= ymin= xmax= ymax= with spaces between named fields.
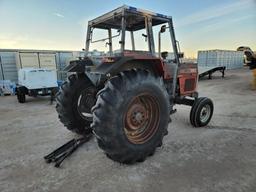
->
xmin=0 ymin=69 xmax=256 ymax=192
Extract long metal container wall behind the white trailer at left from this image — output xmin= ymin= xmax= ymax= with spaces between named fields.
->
xmin=0 ymin=49 xmax=84 ymax=83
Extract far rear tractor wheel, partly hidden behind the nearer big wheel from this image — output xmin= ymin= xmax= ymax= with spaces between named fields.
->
xmin=56 ymin=74 xmax=96 ymax=135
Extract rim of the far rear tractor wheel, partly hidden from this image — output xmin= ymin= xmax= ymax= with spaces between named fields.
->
xmin=77 ymin=88 xmax=96 ymax=121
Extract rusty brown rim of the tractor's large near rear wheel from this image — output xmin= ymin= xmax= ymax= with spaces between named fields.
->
xmin=124 ymin=94 xmax=160 ymax=144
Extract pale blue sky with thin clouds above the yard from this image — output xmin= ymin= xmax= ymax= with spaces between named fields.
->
xmin=0 ymin=0 xmax=256 ymax=57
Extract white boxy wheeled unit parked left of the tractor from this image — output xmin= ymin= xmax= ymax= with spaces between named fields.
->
xmin=16 ymin=68 xmax=58 ymax=103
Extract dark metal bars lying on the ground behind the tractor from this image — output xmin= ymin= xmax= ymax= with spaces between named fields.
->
xmin=44 ymin=134 xmax=92 ymax=168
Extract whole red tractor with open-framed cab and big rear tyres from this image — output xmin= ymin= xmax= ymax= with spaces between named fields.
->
xmin=56 ymin=6 xmax=213 ymax=164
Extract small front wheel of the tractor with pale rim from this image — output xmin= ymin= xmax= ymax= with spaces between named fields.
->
xmin=190 ymin=97 xmax=214 ymax=127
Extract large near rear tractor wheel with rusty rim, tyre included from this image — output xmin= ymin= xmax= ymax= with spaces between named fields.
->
xmin=91 ymin=70 xmax=170 ymax=164
